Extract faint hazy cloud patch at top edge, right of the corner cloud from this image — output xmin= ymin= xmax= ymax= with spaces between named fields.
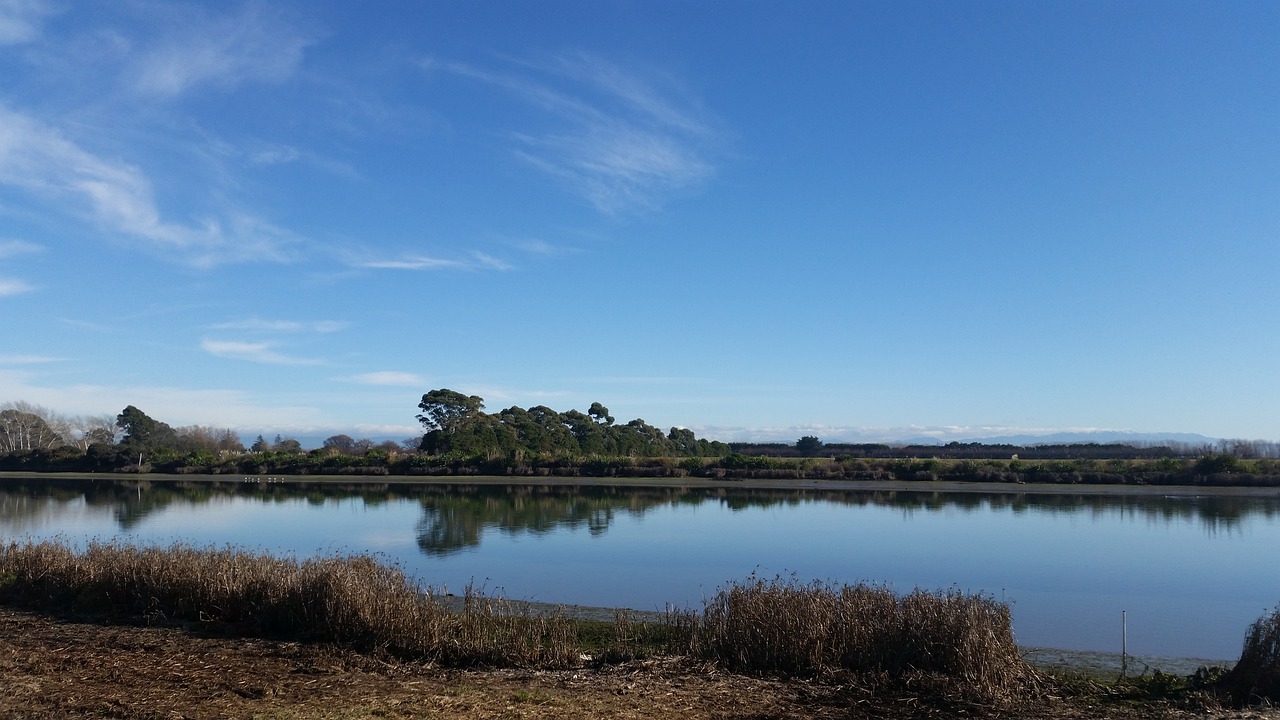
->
xmin=134 ymin=3 xmax=315 ymax=96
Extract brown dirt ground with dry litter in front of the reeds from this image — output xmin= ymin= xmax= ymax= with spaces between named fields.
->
xmin=0 ymin=609 xmax=1280 ymax=720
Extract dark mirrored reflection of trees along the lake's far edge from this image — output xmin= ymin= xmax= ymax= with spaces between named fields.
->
xmin=0 ymin=478 xmax=1280 ymax=548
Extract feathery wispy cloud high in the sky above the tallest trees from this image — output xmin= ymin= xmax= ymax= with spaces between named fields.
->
xmin=440 ymin=53 xmax=717 ymax=214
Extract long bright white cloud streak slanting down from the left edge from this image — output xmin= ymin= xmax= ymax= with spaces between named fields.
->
xmin=0 ymin=106 xmax=297 ymax=266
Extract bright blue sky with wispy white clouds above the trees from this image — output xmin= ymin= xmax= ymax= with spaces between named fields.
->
xmin=0 ymin=0 xmax=1280 ymax=442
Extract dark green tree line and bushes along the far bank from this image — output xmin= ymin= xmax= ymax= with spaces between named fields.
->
xmin=0 ymin=388 xmax=1280 ymax=484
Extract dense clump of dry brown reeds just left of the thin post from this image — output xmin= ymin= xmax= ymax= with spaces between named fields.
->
xmin=698 ymin=571 xmax=1037 ymax=700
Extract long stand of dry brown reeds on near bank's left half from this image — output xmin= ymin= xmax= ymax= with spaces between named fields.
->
xmin=0 ymin=542 xmax=577 ymax=666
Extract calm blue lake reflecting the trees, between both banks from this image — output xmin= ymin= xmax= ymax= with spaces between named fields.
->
xmin=0 ymin=478 xmax=1280 ymax=660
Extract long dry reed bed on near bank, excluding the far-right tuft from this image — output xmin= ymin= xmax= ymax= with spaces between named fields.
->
xmin=0 ymin=541 xmax=1038 ymax=701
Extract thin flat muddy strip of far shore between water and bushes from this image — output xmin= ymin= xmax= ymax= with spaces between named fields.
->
xmin=0 ymin=471 xmax=1280 ymax=498
